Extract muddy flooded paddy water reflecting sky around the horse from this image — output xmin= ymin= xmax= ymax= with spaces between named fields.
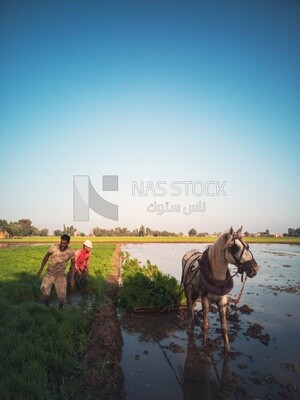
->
xmin=120 ymin=244 xmax=300 ymax=400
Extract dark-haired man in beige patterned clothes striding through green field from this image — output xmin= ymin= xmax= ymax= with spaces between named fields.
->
xmin=37 ymin=234 xmax=75 ymax=309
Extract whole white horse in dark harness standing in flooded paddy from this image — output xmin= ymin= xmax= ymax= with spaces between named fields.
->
xmin=181 ymin=226 xmax=258 ymax=351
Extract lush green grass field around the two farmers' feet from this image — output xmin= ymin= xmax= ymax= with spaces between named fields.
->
xmin=0 ymin=244 xmax=115 ymax=400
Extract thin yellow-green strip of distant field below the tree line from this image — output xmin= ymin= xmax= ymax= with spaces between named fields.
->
xmin=0 ymin=236 xmax=300 ymax=245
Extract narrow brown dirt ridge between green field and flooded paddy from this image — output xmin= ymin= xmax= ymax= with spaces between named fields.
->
xmin=83 ymin=244 xmax=125 ymax=400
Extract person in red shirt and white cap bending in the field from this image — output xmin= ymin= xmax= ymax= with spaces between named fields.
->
xmin=68 ymin=240 xmax=93 ymax=294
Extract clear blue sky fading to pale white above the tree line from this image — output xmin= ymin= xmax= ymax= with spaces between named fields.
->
xmin=0 ymin=0 xmax=300 ymax=233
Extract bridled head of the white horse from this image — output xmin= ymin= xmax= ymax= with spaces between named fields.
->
xmin=225 ymin=226 xmax=259 ymax=278
